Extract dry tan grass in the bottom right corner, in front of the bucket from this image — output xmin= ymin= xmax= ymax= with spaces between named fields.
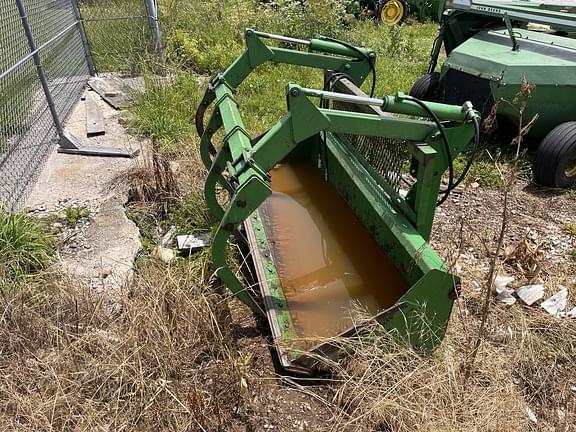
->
xmin=310 ymin=280 xmax=576 ymax=432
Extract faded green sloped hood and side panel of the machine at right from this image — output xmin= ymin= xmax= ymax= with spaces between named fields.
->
xmin=442 ymin=29 xmax=576 ymax=137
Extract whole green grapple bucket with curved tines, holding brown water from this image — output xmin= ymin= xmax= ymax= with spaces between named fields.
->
xmin=196 ymin=29 xmax=479 ymax=373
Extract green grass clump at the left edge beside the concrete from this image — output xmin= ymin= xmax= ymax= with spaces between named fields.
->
xmin=0 ymin=210 xmax=55 ymax=279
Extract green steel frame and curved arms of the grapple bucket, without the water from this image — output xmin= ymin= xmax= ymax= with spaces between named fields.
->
xmin=197 ymin=30 xmax=474 ymax=365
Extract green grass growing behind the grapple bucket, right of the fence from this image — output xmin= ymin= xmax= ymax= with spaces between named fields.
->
xmin=133 ymin=0 xmax=437 ymax=153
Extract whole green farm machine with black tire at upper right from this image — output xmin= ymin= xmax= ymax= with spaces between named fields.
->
xmin=410 ymin=0 xmax=576 ymax=188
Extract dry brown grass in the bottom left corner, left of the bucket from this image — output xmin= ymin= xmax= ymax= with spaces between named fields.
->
xmin=0 ymin=264 xmax=252 ymax=431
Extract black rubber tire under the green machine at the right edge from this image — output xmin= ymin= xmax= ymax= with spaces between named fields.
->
xmin=533 ymin=121 xmax=576 ymax=188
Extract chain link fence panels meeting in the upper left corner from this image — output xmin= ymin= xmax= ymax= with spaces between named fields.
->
xmin=0 ymin=0 xmax=160 ymax=210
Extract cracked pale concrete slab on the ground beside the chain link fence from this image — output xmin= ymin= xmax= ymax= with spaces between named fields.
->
xmin=26 ymin=82 xmax=150 ymax=290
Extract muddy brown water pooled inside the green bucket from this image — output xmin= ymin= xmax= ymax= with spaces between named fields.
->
xmin=267 ymin=162 xmax=408 ymax=341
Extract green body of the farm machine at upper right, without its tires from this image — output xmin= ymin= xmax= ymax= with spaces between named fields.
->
xmin=428 ymin=0 xmax=576 ymax=138
